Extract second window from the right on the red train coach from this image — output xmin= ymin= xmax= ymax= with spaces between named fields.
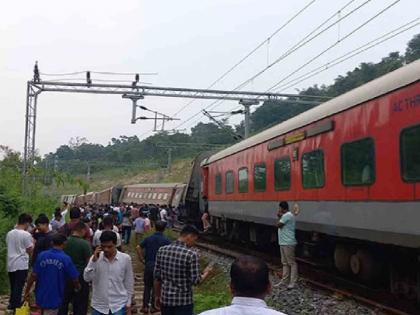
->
xmin=341 ymin=138 xmax=375 ymax=186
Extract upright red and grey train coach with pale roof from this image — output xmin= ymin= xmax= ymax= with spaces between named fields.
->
xmin=201 ymin=61 xmax=420 ymax=294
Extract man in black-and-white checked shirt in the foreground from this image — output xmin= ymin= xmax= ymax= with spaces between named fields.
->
xmin=154 ymin=225 xmax=212 ymax=315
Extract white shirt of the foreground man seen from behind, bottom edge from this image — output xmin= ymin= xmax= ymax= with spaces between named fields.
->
xmin=200 ymin=296 xmax=286 ymax=315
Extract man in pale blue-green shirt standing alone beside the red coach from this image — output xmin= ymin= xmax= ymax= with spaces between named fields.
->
xmin=277 ymin=201 xmax=298 ymax=289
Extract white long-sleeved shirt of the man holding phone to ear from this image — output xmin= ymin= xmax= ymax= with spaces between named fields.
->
xmin=83 ymin=251 xmax=134 ymax=314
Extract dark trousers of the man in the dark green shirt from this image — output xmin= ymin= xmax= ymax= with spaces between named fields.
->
xmin=58 ymin=274 xmax=89 ymax=315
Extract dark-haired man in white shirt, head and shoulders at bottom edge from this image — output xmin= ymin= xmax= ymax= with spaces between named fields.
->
xmin=200 ymin=256 xmax=285 ymax=315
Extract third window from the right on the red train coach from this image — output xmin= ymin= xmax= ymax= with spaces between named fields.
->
xmin=302 ymin=150 xmax=325 ymax=188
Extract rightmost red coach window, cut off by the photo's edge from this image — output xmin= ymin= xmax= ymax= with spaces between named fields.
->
xmin=400 ymin=125 xmax=420 ymax=182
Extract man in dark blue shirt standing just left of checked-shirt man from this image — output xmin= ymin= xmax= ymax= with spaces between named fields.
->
xmin=137 ymin=221 xmax=171 ymax=314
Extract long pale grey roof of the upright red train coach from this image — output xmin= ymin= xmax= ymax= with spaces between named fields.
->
xmin=201 ymin=60 xmax=420 ymax=165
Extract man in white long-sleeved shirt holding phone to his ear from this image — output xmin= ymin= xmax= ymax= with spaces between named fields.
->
xmin=83 ymin=231 xmax=134 ymax=315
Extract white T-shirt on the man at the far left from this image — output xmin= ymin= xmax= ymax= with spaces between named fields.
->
xmin=6 ymin=229 xmax=34 ymax=272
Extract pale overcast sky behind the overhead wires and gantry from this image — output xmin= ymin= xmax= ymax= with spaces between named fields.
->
xmin=0 ymin=0 xmax=420 ymax=154
